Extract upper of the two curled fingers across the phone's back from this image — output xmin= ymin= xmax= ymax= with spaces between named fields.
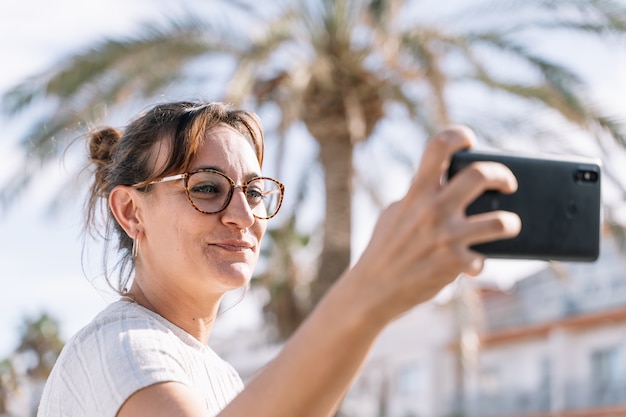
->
xmin=442 ymin=162 xmax=517 ymax=212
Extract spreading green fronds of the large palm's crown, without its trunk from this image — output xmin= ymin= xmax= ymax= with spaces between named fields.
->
xmin=0 ymin=0 xmax=626 ymax=208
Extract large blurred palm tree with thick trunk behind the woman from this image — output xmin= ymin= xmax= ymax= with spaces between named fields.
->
xmin=2 ymin=0 xmax=626 ymax=322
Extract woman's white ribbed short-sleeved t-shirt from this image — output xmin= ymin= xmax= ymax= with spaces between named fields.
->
xmin=37 ymin=300 xmax=243 ymax=417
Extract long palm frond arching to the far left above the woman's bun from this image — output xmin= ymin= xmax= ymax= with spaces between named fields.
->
xmin=0 ymin=17 xmax=234 ymax=204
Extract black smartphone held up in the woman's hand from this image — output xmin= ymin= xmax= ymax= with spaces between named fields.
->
xmin=448 ymin=150 xmax=602 ymax=262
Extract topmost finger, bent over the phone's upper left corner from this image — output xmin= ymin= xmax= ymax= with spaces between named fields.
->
xmin=409 ymin=125 xmax=476 ymax=193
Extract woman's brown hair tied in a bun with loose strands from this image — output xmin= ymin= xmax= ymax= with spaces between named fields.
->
xmin=86 ymin=101 xmax=264 ymax=294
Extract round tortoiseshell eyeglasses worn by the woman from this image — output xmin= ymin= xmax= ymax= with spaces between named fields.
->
xmin=133 ymin=169 xmax=285 ymax=220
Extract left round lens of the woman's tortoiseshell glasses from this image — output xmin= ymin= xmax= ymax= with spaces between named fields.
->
xmin=187 ymin=172 xmax=230 ymax=213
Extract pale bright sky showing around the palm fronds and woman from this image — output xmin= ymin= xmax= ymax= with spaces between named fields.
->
xmin=0 ymin=0 xmax=626 ymax=358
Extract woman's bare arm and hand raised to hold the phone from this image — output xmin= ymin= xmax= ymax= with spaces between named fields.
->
xmin=118 ymin=127 xmax=520 ymax=417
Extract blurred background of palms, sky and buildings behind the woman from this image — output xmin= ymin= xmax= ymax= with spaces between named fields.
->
xmin=0 ymin=0 xmax=626 ymax=417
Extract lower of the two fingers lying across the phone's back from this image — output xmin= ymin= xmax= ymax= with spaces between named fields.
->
xmin=458 ymin=210 xmax=522 ymax=246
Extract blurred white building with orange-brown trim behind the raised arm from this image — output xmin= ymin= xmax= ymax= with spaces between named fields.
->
xmin=218 ymin=234 xmax=626 ymax=417
